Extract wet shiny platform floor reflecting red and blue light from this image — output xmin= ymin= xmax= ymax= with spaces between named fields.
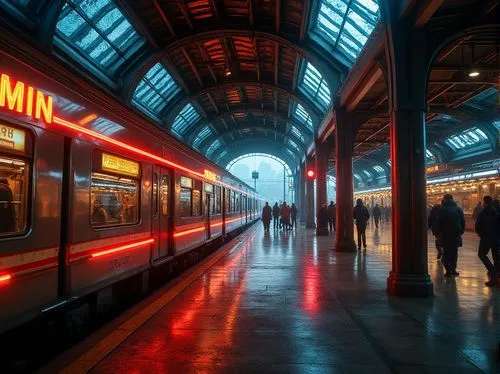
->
xmin=93 ymin=223 xmax=500 ymax=373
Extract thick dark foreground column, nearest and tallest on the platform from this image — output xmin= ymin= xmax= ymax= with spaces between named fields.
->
xmin=381 ymin=2 xmax=433 ymax=297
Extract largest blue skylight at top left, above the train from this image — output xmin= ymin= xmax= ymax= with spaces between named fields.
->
xmin=55 ymin=0 xmax=144 ymax=76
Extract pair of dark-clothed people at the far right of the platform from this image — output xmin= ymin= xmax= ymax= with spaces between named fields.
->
xmin=428 ymin=194 xmax=500 ymax=287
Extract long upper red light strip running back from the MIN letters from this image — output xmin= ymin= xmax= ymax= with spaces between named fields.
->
xmin=52 ymin=116 xmax=256 ymax=197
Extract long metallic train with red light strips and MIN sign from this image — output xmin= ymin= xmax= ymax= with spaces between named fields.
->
xmin=0 ymin=51 xmax=261 ymax=333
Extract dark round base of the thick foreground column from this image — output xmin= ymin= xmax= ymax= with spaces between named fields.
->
xmin=387 ymin=271 xmax=434 ymax=298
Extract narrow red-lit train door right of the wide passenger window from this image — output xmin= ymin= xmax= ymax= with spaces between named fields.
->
xmin=152 ymin=167 xmax=171 ymax=260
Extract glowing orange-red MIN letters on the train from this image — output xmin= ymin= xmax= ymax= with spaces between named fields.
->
xmin=0 ymin=74 xmax=53 ymax=123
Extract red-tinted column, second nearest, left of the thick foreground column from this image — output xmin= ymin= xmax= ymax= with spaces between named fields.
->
xmin=335 ymin=108 xmax=356 ymax=252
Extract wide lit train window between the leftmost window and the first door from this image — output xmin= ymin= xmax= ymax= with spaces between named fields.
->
xmin=90 ymin=172 xmax=140 ymax=228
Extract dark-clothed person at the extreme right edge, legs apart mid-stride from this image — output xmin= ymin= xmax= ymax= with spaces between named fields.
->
xmin=475 ymin=196 xmax=500 ymax=287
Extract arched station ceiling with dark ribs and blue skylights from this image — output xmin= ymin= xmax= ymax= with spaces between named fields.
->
xmin=0 ymin=0 xmax=378 ymax=170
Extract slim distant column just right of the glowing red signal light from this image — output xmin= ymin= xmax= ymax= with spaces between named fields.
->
xmin=315 ymin=140 xmax=330 ymax=236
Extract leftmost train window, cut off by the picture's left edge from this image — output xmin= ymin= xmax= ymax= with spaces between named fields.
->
xmin=0 ymin=156 xmax=30 ymax=236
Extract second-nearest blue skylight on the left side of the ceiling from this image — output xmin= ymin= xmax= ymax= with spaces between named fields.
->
xmin=132 ymin=62 xmax=181 ymax=116
